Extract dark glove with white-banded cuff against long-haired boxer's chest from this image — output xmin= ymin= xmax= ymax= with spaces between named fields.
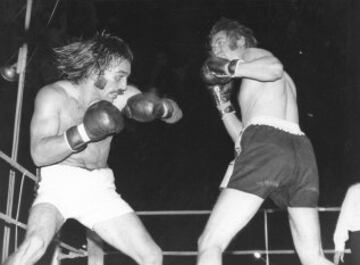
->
xmin=65 ymin=100 xmax=124 ymax=151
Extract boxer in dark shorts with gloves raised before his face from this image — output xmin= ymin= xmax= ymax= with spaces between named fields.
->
xmin=197 ymin=18 xmax=332 ymax=265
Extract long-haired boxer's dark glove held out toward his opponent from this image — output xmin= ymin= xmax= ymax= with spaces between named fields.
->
xmin=123 ymin=93 xmax=182 ymax=123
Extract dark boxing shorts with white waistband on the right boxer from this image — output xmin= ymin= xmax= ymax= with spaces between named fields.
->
xmin=226 ymin=117 xmax=319 ymax=208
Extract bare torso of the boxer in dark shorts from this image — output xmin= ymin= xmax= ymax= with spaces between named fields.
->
xmin=238 ymin=72 xmax=299 ymax=127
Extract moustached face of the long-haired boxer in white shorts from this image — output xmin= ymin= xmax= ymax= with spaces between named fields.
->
xmin=99 ymin=60 xmax=131 ymax=102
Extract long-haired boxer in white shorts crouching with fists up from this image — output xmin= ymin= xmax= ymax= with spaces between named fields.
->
xmin=5 ymin=33 xmax=182 ymax=265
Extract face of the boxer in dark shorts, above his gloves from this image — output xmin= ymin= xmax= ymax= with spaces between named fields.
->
xmin=210 ymin=31 xmax=243 ymax=60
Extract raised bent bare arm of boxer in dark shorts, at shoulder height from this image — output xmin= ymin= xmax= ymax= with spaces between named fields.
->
xmin=233 ymin=48 xmax=284 ymax=82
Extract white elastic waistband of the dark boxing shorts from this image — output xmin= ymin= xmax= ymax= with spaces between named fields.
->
xmin=245 ymin=116 xmax=305 ymax=135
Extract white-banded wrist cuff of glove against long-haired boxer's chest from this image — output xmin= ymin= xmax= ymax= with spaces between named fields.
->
xmin=64 ymin=124 xmax=91 ymax=152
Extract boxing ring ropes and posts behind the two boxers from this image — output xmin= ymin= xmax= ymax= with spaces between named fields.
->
xmin=0 ymin=0 xmax=350 ymax=265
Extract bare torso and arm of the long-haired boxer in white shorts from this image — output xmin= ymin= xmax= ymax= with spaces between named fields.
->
xmin=31 ymin=78 xmax=140 ymax=169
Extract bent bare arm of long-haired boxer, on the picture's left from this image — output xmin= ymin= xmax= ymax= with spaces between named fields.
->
xmin=30 ymin=87 xmax=72 ymax=166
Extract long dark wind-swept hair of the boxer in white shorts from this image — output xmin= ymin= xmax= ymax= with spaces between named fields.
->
xmin=54 ymin=32 xmax=133 ymax=83
